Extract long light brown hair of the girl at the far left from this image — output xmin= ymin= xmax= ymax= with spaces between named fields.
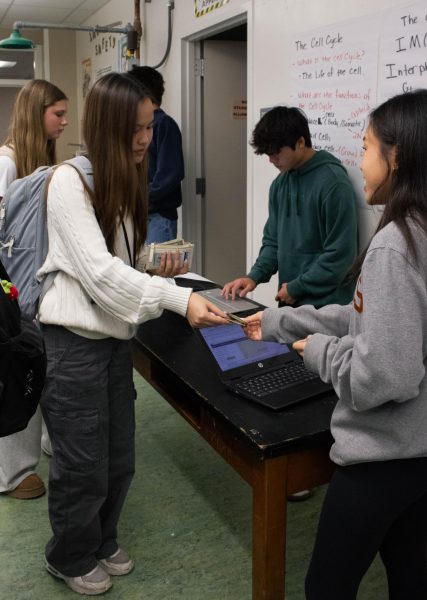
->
xmin=5 ymin=79 xmax=68 ymax=177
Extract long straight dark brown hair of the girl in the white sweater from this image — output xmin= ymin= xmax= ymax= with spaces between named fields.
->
xmin=82 ymin=73 xmax=151 ymax=253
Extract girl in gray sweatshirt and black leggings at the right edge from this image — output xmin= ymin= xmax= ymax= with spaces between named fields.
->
xmin=245 ymin=90 xmax=427 ymax=600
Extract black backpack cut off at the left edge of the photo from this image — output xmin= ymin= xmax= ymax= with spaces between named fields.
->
xmin=0 ymin=262 xmax=46 ymax=437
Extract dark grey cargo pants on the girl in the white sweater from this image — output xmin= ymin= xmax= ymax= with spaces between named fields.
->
xmin=41 ymin=326 xmax=135 ymax=577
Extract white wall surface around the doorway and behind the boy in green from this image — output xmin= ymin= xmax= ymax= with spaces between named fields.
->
xmin=77 ymin=0 xmax=418 ymax=305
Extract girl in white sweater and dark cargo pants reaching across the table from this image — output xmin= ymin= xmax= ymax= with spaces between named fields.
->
xmin=39 ymin=73 xmax=226 ymax=595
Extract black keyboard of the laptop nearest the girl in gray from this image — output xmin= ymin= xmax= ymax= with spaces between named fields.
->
xmin=235 ymin=361 xmax=318 ymax=398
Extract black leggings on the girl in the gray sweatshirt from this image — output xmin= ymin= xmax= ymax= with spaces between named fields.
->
xmin=305 ymin=458 xmax=427 ymax=600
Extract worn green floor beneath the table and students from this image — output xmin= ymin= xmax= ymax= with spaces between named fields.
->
xmin=0 ymin=376 xmax=387 ymax=600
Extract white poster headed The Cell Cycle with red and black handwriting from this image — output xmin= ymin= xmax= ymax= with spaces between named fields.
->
xmin=290 ymin=22 xmax=378 ymax=204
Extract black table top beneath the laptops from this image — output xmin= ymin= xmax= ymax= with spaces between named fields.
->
xmin=135 ymin=281 xmax=336 ymax=457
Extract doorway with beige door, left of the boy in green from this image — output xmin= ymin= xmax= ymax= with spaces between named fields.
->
xmin=183 ymin=15 xmax=248 ymax=284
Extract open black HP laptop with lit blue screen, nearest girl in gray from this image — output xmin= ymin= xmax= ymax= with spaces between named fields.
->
xmin=198 ymin=324 xmax=332 ymax=410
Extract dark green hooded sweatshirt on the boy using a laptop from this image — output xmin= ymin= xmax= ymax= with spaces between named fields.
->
xmin=248 ymin=150 xmax=357 ymax=307
